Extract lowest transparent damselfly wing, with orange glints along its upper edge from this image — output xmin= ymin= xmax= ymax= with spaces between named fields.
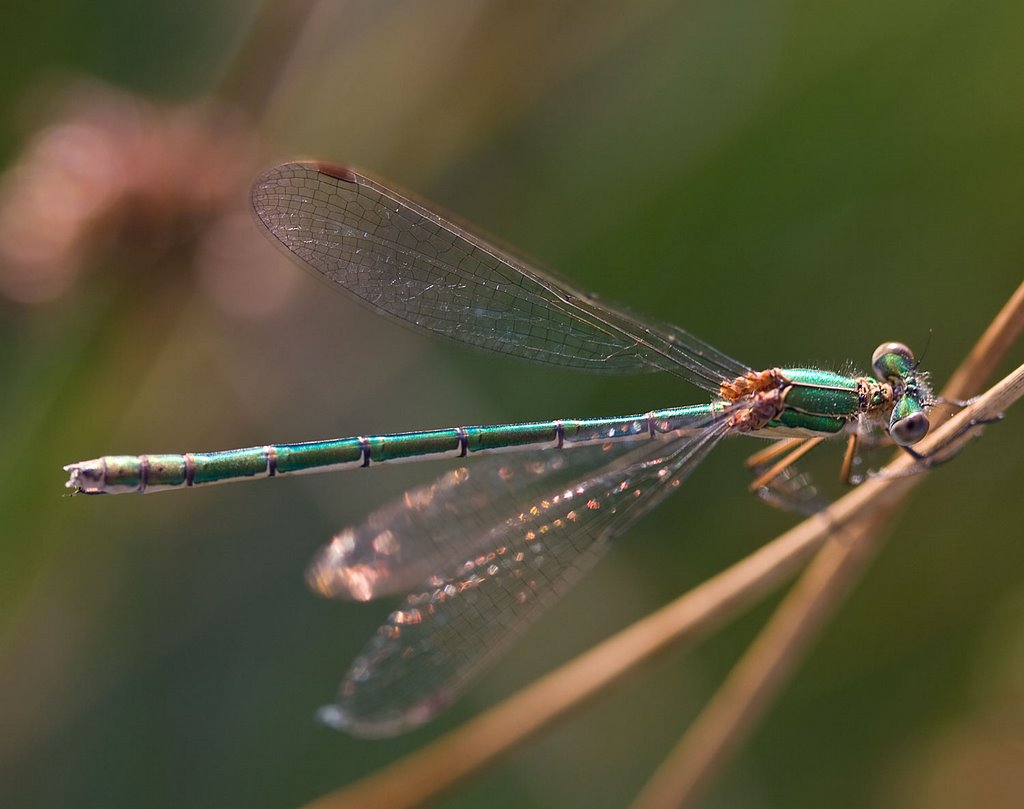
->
xmin=321 ymin=418 xmax=728 ymax=736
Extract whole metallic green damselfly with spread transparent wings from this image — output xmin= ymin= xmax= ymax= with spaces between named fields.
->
xmin=65 ymin=163 xmax=932 ymax=736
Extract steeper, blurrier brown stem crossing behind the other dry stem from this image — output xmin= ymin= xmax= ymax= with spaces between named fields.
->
xmin=634 ymin=285 xmax=1024 ymax=809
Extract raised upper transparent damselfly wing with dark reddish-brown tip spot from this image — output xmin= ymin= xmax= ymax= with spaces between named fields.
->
xmin=252 ymin=163 xmax=749 ymax=392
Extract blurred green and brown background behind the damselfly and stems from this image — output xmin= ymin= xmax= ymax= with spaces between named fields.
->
xmin=0 ymin=0 xmax=1024 ymax=807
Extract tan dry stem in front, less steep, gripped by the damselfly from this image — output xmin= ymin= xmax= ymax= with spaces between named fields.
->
xmin=305 ymin=280 xmax=1024 ymax=809
